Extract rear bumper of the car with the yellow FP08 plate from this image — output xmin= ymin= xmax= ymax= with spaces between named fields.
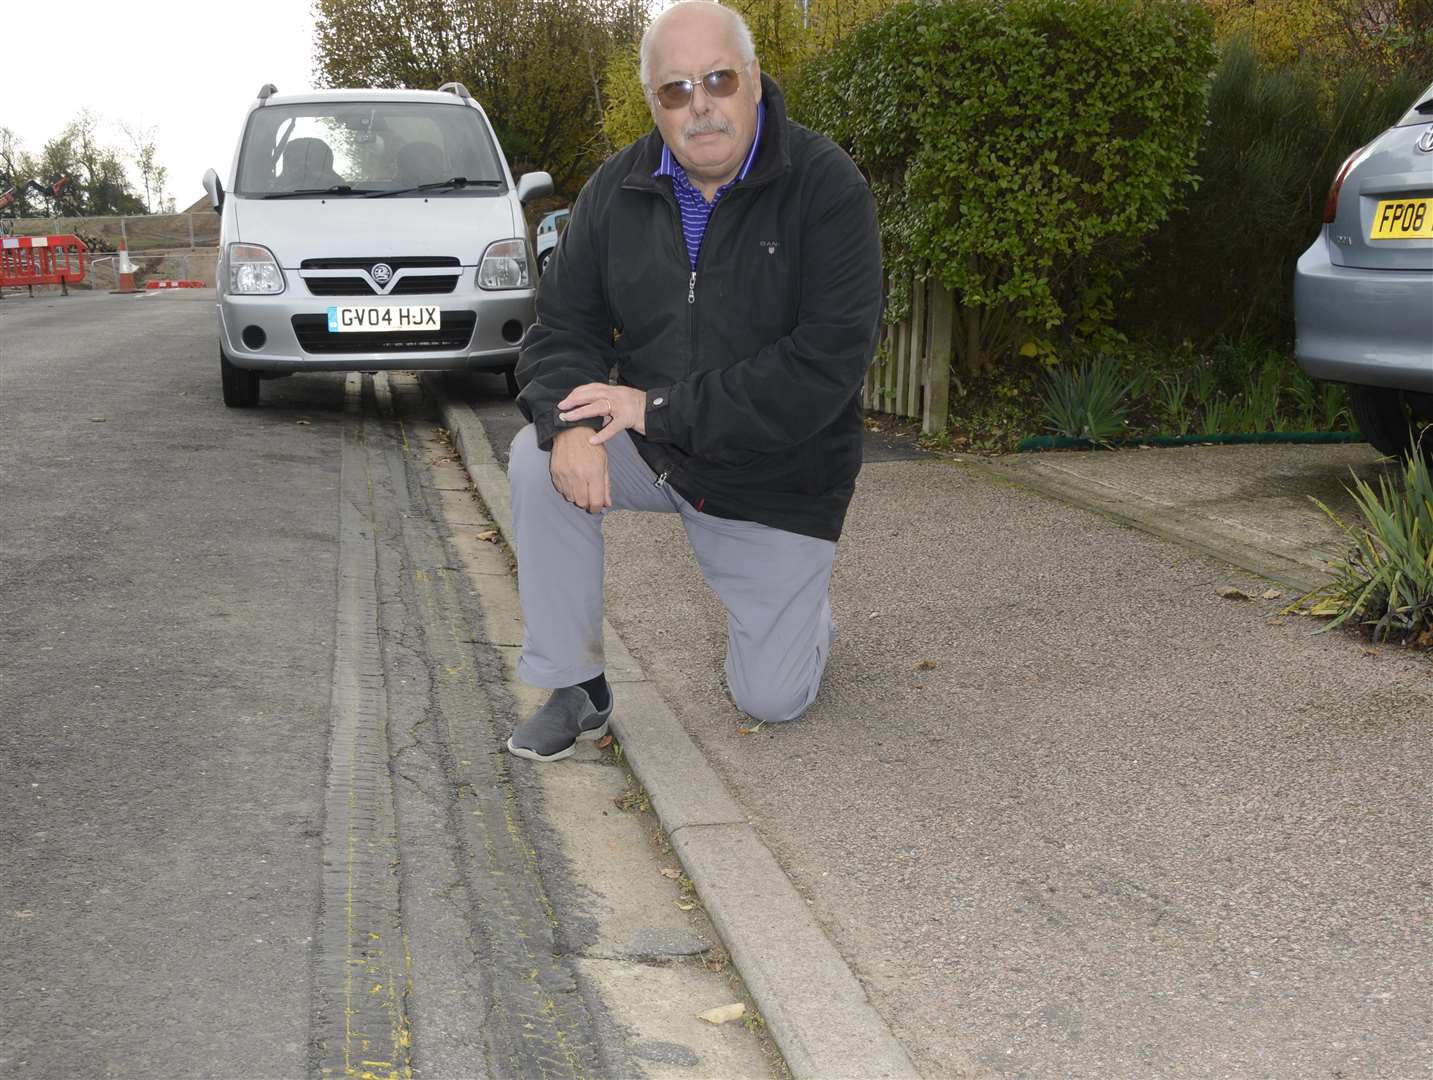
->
xmin=1294 ymin=235 xmax=1433 ymax=394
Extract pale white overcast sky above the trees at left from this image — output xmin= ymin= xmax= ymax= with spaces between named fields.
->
xmin=0 ymin=0 xmax=314 ymax=211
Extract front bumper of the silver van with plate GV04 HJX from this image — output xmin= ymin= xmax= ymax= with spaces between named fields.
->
xmin=218 ymin=284 xmax=537 ymax=372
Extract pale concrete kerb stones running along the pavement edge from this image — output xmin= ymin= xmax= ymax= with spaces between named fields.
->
xmin=423 ymin=375 xmax=920 ymax=1080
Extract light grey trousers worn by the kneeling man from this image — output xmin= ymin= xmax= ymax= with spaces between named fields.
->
xmin=507 ymin=424 xmax=835 ymax=723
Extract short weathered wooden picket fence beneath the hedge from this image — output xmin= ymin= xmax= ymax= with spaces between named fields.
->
xmin=861 ymin=270 xmax=954 ymax=433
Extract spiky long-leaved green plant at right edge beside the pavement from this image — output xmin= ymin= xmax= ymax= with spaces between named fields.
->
xmin=1305 ymin=454 xmax=1433 ymax=645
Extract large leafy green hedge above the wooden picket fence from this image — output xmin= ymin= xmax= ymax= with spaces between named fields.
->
xmin=797 ymin=0 xmax=1215 ymax=374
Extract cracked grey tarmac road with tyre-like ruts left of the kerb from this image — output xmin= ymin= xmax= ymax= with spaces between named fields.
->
xmin=0 ymin=294 xmax=699 ymax=1077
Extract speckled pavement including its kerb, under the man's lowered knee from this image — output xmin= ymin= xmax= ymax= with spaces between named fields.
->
xmin=431 ymin=378 xmax=1433 ymax=1080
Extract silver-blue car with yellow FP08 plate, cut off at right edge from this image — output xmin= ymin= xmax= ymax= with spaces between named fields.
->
xmin=1294 ymin=78 xmax=1433 ymax=460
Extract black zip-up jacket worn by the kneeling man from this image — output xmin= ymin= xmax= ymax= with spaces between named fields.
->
xmin=517 ymin=76 xmax=883 ymax=540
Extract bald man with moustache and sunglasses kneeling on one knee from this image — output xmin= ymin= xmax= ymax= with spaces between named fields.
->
xmin=507 ymin=0 xmax=881 ymax=761
